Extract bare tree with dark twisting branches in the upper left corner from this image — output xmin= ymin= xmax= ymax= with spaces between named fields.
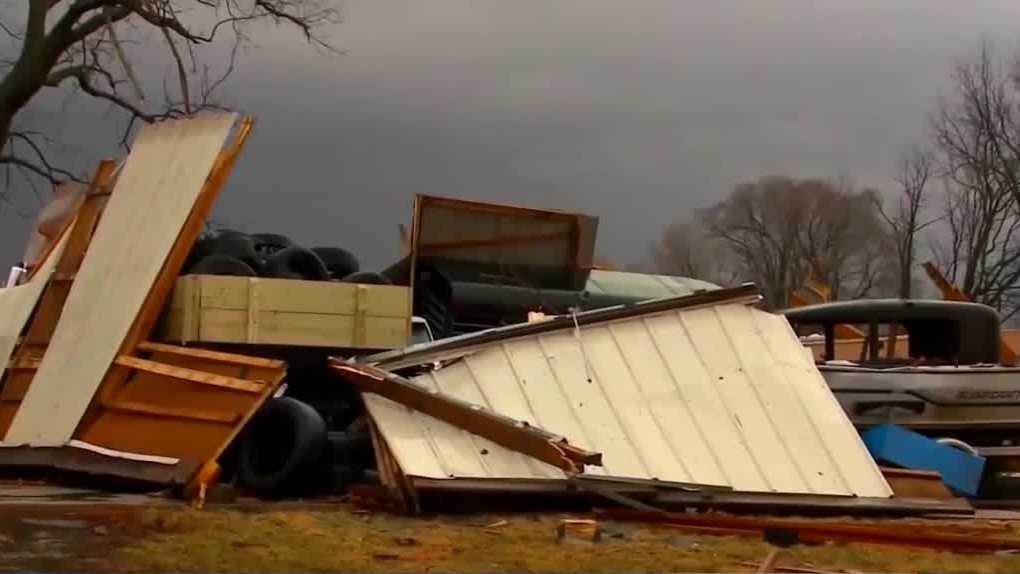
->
xmin=0 ymin=0 xmax=338 ymax=196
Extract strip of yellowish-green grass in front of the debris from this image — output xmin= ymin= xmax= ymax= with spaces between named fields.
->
xmin=110 ymin=506 xmax=1020 ymax=572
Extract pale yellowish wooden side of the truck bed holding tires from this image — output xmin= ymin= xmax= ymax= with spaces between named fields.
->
xmin=157 ymin=275 xmax=411 ymax=350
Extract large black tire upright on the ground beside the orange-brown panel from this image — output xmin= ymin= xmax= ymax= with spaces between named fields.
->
xmin=238 ymin=397 xmax=327 ymax=498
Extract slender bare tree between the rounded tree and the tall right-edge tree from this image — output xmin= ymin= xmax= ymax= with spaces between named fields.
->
xmin=875 ymin=147 xmax=937 ymax=299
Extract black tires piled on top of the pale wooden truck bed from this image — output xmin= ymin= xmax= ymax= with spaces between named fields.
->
xmin=184 ymin=229 xmax=391 ymax=284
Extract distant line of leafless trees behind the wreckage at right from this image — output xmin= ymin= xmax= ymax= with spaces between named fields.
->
xmin=650 ymin=40 xmax=1020 ymax=318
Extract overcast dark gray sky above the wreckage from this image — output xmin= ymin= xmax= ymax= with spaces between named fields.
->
xmin=0 ymin=0 xmax=1020 ymax=268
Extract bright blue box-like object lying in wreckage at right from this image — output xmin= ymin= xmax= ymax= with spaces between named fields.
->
xmin=861 ymin=424 xmax=984 ymax=497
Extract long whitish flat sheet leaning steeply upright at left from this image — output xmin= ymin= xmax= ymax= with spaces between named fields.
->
xmin=5 ymin=114 xmax=236 ymax=447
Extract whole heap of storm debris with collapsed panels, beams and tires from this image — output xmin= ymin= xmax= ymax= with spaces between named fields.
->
xmin=0 ymin=114 xmax=1020 ymax=562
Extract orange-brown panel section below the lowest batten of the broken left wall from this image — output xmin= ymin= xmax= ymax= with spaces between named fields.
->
xmin=75 ymin=409 xmax=234 ymax=462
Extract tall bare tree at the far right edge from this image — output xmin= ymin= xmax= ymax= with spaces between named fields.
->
xmin=932 ymin=41 xmax=1020 ymax=317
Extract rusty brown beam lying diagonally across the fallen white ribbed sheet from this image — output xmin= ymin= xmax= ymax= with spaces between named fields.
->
xmin=329 ymin=358 xmax=602 ymax=472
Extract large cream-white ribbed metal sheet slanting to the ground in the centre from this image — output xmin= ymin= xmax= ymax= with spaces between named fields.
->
xmin=365 ymin=304 xmax=891 ymax=497
